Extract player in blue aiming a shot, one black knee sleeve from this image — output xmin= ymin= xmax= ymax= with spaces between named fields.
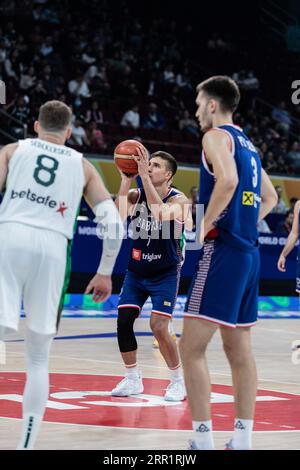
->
xmin=112 ymin=145 xmax=192 ymax=401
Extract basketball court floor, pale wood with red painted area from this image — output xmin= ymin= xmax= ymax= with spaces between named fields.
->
xmin=0 ymin=317 xmax=300 ymax=450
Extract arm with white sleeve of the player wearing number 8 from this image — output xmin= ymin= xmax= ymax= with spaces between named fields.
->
xmin=83 ymin=159 xmax=124 ymax=302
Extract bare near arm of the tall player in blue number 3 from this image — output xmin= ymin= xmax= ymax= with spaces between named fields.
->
xmin=202 ymin=130 xmax=239 ymax=238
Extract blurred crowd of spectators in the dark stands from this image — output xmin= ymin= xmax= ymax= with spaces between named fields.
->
xmin=0 ymin=0 xmax=300 ymax=229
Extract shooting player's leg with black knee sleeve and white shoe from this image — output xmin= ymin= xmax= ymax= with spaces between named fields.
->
xmin=111 ymin=271 xmax=148 ymax=396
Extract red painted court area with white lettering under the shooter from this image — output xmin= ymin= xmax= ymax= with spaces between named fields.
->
xmin=0 ymin=372 xmax=300 ymax=431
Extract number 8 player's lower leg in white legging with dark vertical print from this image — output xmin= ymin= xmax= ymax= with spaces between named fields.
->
xmin=17 ymin=330 xmax=53 ymax=450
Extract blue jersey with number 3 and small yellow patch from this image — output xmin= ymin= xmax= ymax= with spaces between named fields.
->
xmin=199 ymin=124 xmax=261 ymax=251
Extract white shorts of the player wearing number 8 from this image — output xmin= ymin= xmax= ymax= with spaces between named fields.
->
xmin=0 ymin=222 xmax=68 ymax=335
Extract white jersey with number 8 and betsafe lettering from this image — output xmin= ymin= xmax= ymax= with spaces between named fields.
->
xmin=0 ymin=139 xmax=85 ymax=239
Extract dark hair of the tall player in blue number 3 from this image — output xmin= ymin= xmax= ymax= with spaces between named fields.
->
xmin=197 ymin=75 xmax=241 ymax=113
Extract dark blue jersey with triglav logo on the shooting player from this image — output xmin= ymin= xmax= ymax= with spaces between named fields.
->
xmin=128 ymin=188 xmax=185 ymax=277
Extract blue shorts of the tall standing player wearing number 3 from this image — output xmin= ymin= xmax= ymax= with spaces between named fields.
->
xmin=184 ymin=238 xmax=260 ymax=328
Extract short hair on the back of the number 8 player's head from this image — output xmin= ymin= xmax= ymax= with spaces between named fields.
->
xmin=38 ymin=100 xmax=72 ymax=132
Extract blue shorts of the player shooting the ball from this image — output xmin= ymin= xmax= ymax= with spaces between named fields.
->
xmin=118 ymin=266 xmax=180 ymax=318
